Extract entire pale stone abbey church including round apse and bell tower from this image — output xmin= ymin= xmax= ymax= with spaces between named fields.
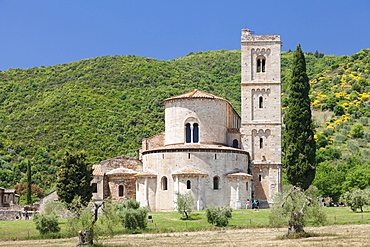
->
xmin=93 ymin=29 xmax=282 ymax=211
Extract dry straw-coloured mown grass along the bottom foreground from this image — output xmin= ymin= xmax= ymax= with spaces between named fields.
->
xmin=0 ymin=225 xmax=370 ymax=247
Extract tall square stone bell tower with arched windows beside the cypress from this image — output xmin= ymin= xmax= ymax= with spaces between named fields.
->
xmin=241 ymin=29 xmax=282 ymax=203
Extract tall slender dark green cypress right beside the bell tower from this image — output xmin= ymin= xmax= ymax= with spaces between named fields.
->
xmin=283 ymin=45 xmax=316 ymax=190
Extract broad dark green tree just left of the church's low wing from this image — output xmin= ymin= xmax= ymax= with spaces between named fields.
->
xmin=56 ymin=152 xmax=92 ymax=206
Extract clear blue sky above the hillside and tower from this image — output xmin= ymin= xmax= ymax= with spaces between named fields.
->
xmin=0 ymin=0 xmax=370 ymax=70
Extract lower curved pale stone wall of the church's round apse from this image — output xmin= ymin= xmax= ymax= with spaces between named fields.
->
xmin=137 ymin=149 xmax=250 ymax=211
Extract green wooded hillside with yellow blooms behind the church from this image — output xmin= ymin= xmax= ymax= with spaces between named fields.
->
xmin=0 ymin=50 xmax=370 ymax=196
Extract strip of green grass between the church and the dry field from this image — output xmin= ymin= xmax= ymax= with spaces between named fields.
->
xmin=0 ymin=207 xmax=370 ymax=240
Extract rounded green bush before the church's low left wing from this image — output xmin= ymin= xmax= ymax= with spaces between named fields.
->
xmin=116 ymin=199 xmax=148 ymax=230
